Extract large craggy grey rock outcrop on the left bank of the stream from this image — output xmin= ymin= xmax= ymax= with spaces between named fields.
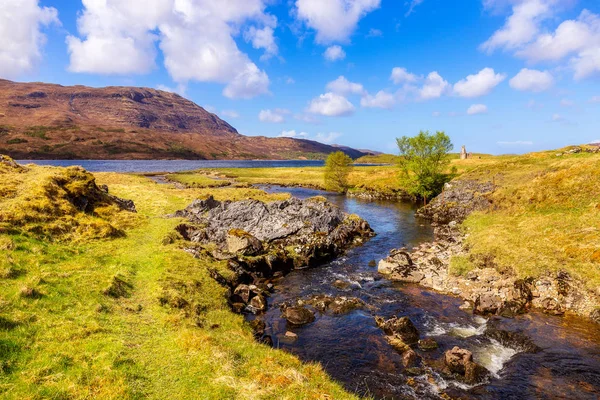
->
xmin=172 ymin=197 xmax=374 ymax=313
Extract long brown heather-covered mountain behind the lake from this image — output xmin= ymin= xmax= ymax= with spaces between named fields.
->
xmin=0 ymin=80 xmax=364 ymax=160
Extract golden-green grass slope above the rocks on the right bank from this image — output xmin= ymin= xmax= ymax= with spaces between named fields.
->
xmin=453 ymin=151 xmax=600 ymax=289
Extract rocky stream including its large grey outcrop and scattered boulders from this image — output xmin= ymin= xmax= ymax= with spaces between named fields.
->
xmin=177 ymin=186 xmax=600 ymax=399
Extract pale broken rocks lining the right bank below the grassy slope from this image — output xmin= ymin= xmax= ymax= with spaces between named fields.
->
xmin=378 ymin=214 xmax=600 ymax=317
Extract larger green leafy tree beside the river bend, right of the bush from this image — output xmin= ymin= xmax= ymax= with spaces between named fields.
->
xmin=396 ymin=131 xmax=454 ymax=204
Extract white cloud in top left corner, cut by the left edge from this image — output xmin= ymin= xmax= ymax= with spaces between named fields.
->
xmin=0 ymin=0 xmax=60 ymax=78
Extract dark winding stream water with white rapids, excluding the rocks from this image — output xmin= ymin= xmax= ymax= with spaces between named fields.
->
xmin=248 ymin=186 xmax=600 ymax=399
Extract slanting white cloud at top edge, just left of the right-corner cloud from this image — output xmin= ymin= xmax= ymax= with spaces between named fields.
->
xmin=480 ymin=0 xmax=554 ymax=52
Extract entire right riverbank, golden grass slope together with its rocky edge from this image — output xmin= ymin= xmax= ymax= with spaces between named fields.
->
xmin=380 ymin=147 xmax=600 ymax=322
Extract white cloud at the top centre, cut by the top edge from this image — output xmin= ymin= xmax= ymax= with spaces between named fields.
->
xmin=296 ymin=0 xmax=381 ymax=44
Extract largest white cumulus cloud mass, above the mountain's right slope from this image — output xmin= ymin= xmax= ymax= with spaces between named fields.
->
xmin=67 ymin=0 xmax=277 ymax=98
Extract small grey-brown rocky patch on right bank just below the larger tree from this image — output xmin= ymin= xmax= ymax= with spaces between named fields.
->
xmin=417 ymin=180 xmax=494 ymax=224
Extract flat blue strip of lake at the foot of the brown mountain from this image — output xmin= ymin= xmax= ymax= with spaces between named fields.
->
xmin=17 ymin=160 xmax=384 ymax=173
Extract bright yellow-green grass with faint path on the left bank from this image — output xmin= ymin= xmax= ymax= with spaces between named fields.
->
xmin=0 ymin=164 xmax=354 ymax=399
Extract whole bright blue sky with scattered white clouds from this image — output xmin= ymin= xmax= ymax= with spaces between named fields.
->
xmin=0 ymin=0 xmax=600 ymax=154
